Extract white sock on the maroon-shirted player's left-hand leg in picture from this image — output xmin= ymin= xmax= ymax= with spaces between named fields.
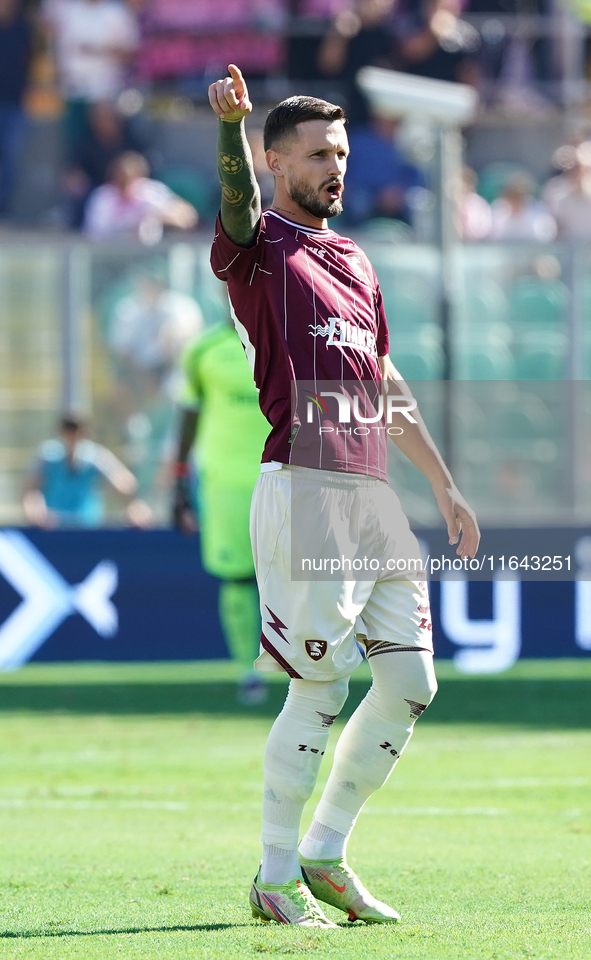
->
xmin=261 ymin=680 xmax=348 ymax=884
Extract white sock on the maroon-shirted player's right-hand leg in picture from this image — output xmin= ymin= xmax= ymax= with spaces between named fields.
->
xmin=300 ymin=643 xmax=437 ymax=844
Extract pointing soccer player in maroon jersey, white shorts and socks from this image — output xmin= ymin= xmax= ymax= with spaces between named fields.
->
xmin=209 ymin=65 xmax=479 ymax=927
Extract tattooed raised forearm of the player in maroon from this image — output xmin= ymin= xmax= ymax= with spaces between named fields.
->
xmin=218 ymin=120 xmax=261 ymax=247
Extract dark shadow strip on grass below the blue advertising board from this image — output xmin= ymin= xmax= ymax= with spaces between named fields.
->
xmin=0 ymin=677 xmax=591 ymax=729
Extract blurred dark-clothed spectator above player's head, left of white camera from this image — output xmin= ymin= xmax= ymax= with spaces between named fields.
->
xmin=318 ymin=0 xmax=395 ymax=125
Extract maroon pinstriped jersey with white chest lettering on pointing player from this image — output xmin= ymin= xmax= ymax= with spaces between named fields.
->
xmin=211 ymin=210 xmax=388 ymax=480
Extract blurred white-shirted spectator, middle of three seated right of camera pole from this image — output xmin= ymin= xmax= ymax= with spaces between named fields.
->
xmin=490 ymin=173 xmax=556 ymax=243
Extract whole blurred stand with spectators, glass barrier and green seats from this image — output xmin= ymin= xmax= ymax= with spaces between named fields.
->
xmin=0 ymin=0 xmax=591 ymax=524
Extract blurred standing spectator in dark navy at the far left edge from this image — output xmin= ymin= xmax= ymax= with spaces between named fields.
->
xmin=0 ymin=0 xmax=31 ymax=217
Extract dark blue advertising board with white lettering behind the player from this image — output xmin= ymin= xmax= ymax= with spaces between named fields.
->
xmin=0 ymin=528 xmax=591 ymax=673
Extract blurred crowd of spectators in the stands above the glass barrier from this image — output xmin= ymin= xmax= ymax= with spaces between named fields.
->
xmin=0 ymin=0 xmax=591 ymax=233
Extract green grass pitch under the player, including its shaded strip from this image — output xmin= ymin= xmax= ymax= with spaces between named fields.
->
xmin=0 ymin=660 xmax=591 ymax=960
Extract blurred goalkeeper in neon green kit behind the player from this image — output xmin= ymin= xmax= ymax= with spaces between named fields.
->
xmin=173 ymin=322 xmax=269 ymax=704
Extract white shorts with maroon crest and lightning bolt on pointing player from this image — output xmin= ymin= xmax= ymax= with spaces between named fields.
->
xmin=250 ymin=465 xmax=433 ymax=680
